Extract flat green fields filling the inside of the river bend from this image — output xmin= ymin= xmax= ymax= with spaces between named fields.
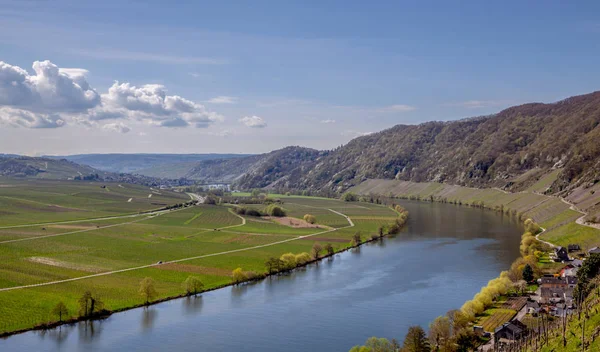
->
xmin=0 ymin=179 xmax=404 ymax=333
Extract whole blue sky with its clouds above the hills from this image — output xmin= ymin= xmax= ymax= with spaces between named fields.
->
xmin=0 ymin=0 xmax=600 ymax=155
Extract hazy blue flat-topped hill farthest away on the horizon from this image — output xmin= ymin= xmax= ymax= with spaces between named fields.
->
xmin=45 ymin=154 xmax=249 ymax=174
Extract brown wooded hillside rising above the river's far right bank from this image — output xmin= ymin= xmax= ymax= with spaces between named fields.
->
xmin=219 ymin=92 xmax=600 ymax=193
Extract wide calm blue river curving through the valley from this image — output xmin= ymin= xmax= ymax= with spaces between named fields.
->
xmin=0 ymin=201 xmax=521 ymax=352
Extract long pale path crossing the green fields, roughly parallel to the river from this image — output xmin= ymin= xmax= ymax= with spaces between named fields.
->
xmin=0 ymin=209 xmax=354 ymax=292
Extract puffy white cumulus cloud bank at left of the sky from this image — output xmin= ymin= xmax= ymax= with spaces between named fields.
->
xmin=0 ymin=61 xmax=224 ymax=133
